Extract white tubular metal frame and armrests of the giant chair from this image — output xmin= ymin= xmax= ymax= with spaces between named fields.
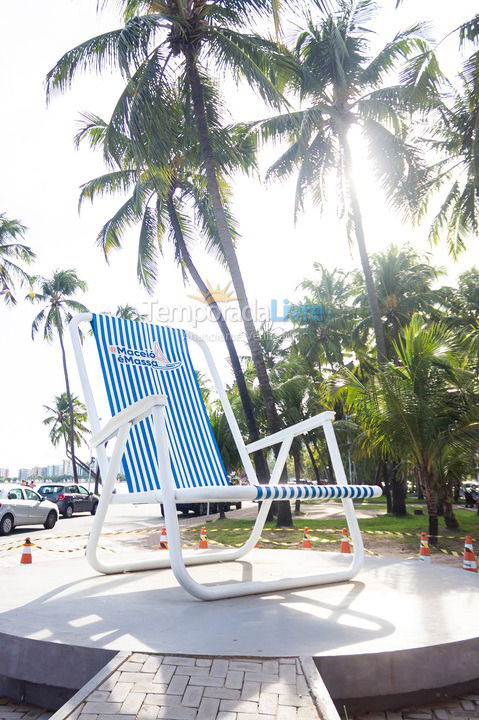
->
xmin=70 ymin=313 xmax=372 ymax=600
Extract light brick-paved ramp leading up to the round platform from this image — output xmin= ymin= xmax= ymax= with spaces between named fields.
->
xmin=64 ymin=656 xmax=319 ymax=720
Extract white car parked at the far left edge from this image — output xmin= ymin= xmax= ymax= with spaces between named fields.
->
xmin=0 ymin=483 xmax=58 ymax=535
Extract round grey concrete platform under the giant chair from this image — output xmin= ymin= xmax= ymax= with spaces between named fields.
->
xmin=0 ymin=550 xmax=479 ymax=698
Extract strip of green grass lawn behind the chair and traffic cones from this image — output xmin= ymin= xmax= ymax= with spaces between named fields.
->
xmin=181 ymin=504 xmax=479 ymax=553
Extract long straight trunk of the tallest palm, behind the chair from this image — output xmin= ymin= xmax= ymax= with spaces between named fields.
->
xmin=183 ymin=46 xmax=293 ymax=527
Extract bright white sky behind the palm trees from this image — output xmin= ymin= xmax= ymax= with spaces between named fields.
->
xmin=0 ymin=0 xmax=479 ymax=475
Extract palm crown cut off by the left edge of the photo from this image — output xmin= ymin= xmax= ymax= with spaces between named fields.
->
xmin=0 ymin=213 xmax=36 ymax=305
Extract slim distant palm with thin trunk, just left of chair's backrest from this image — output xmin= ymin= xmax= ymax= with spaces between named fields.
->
xmin=27 ymin=270 xmax=87 ymax=482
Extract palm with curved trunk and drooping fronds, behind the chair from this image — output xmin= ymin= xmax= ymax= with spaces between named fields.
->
xmin=77 ymin=107 xmax=269 ymax=482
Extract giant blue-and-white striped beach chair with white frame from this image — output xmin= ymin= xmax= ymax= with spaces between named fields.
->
xmin=70 ymin=313 xmax=381 ymax=600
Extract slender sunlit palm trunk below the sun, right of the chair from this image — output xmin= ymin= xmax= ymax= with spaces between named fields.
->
xmin=340 ymin=133 xmax=387 ymax=365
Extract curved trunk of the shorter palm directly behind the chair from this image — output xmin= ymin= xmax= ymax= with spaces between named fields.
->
xmin=167 ymin=193 xmax=270 ymax=483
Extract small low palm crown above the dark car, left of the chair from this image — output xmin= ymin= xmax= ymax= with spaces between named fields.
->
xmin=43 ymin=392 xmax=89 ymax=457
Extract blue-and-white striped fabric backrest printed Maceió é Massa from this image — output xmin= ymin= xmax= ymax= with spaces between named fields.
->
xmin=91 ymin=314 xmax=229 ymax=492
